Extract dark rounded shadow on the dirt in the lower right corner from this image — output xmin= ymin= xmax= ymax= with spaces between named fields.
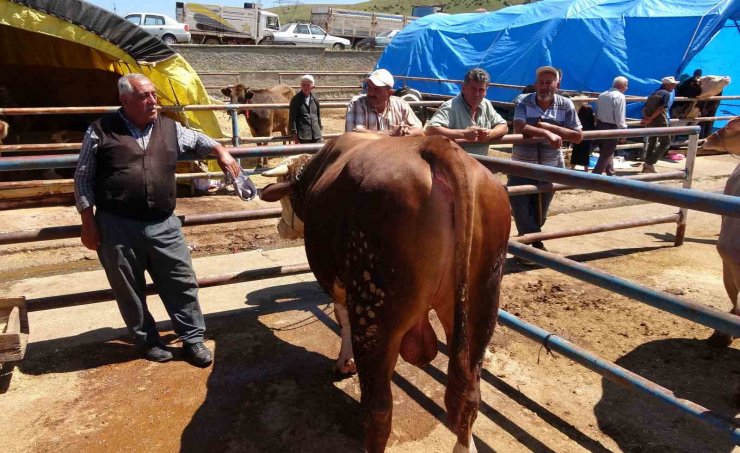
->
xmin=594 ymin=339 xmax=740 ymax=453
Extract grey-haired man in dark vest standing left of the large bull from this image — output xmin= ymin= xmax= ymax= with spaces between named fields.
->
xmin=75 ymin=74 xmax=240 ymax=367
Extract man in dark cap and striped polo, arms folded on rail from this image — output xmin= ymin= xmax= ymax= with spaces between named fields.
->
xmin=507 ymin=66 xmax=583 ymax=264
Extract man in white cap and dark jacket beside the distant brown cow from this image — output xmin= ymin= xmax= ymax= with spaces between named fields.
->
xmin=288 ymin=74 xmax=324 ymax=145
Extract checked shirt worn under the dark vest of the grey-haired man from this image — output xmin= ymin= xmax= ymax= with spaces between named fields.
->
xmin=75 ymin=109 xmax=218 ymax=212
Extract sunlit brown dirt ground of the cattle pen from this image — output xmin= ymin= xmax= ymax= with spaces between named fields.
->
xmin=0 ymin=110 xmax=740 ymax=452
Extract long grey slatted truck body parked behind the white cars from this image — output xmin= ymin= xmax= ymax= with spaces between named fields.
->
xmin=311 ymin=6 xmax=416 ymax=47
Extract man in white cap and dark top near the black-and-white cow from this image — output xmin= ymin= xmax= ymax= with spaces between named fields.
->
xmin=640 ymin=76 xmax=678 ymax=173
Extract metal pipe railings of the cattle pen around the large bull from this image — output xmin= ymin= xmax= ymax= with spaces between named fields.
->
xmin=0 ymin=94 xmax=740 ymax=445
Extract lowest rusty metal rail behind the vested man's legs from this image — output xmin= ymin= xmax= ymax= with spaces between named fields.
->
xmin=26 ymin=263 xmax=311 ymax=311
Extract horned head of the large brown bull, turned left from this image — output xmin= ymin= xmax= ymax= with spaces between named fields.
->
xmin=260 ymin=154 xmax=312 ymax=239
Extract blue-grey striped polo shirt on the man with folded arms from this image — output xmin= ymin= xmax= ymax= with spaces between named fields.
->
xmin=511 ymin=93 xmax=583 ymax=168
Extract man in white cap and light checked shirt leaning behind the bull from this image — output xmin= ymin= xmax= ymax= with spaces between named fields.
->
xmin=344 ymin=69 xmax=423 ymax=137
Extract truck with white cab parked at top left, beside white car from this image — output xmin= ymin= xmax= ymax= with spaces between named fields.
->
xmin=175 ymin=2 xmax=280 ymax=44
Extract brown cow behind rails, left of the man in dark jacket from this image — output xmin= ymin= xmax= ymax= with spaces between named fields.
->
xmin=221 ymin=83 xmax=295 ymax=164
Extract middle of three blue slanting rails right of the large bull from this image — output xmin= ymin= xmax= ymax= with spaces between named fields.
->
xmin=508 ymin=244 xmax=740 ymax=337
